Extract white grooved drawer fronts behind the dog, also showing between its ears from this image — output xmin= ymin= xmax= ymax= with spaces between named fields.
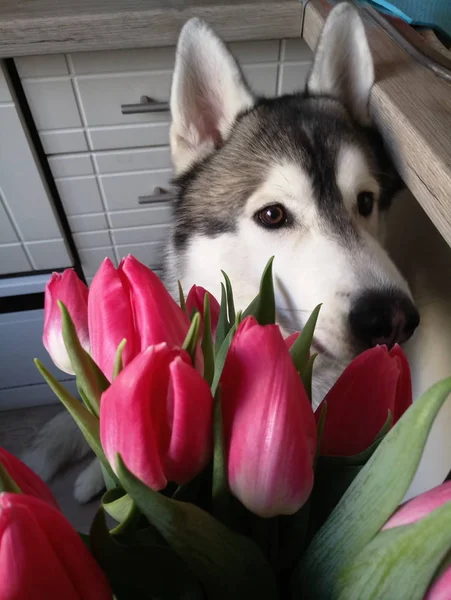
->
xmin=16 ymin=40 xmax=311 ymax=279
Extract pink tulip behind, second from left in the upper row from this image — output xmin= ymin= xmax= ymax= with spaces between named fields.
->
xmin=88 ymin=256 xmax=195 ymax=380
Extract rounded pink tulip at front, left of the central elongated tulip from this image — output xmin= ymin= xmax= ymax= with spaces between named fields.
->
xmin=100 ymin=344 xmax=213 ymax=490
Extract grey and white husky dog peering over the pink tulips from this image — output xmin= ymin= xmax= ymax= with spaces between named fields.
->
xmin=25 ymin=3 xmax=419 ymax=502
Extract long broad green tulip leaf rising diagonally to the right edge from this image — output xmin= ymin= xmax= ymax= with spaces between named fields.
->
xmin=293 ymin=377 xmax=451 ymax=600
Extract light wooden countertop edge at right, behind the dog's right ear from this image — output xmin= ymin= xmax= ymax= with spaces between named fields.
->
xmin=303 ymin=0 xmax=451 ymax=246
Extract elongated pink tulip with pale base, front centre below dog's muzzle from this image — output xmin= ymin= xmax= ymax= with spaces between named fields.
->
xmin=221 ymin=317 xmax=316 ymax=517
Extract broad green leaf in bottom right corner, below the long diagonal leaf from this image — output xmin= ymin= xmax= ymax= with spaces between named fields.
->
xmin=335 ymin=502 xmax=451 ymax=600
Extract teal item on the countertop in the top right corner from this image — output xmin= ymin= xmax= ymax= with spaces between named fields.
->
xmin=360 ymin=0 xmax=451 ymax=37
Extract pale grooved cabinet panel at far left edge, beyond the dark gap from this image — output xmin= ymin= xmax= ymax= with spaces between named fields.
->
xmin=0 ymin=67 xmax=72 ymax=276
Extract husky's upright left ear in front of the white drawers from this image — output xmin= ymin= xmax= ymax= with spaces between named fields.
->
xmin=171 ymin=19 xmax=254 ymax=173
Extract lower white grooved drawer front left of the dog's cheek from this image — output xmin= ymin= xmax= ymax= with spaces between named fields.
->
xmin=49 ymin=146 xmax=173 ymax=281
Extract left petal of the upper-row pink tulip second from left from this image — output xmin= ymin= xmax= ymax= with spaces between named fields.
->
xmin=88 ymin=258 xmax=139 ymax=381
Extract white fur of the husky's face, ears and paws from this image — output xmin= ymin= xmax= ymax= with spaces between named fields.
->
xmin=25 ymin=4 xmax=450 ymax=502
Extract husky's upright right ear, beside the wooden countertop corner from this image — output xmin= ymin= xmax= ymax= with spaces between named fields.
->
xmin=307 ymin=2 xmax=374 ymax=125
